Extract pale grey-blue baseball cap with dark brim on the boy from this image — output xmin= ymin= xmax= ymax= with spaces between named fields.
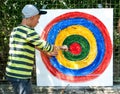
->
xmin=22 ymin=4 xmax=47 ymax=18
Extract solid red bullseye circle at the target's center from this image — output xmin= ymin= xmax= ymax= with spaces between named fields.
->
xmin=69 ymin=42 xmax=82 ymax=55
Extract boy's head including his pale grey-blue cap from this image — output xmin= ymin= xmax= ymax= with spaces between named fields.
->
xmin=22 ymin=4 xmax=47 ymax=28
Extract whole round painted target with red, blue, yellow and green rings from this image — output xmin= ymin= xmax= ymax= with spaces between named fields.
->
xmin=41 ymin=12 xmax=112 ymax=82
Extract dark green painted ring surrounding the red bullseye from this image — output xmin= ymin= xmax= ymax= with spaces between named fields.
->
xmin=63 ymin=35 xmax=90 ymax=61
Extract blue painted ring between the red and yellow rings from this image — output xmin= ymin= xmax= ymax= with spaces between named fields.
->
xmin=47 ymin=18 xmax=105 ymax=76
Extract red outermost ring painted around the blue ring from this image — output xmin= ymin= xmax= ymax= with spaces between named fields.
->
xmin=41 ymin=12 xmax=113 ymax=82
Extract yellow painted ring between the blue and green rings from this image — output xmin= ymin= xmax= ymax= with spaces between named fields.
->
xmin=55 ymin=25 xmax=97 ymax=69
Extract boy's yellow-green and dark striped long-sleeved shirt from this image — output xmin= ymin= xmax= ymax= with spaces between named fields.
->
xmin=6 ymin=25 xmax=53 ymax=79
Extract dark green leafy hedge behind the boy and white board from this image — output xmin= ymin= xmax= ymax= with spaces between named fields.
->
xmin=0 ymin=0 xmax=120 ymax=83
